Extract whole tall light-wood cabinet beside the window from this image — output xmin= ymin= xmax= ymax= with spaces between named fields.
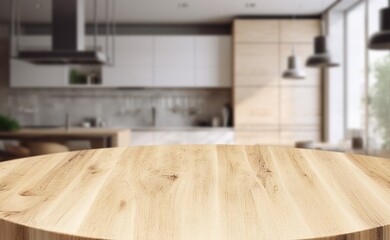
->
xmin=233 ymin=19 xmax=322 ymax=145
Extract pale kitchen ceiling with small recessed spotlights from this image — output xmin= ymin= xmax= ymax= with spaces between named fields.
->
xmin=0 ymin=0 xmax=336 ymax=24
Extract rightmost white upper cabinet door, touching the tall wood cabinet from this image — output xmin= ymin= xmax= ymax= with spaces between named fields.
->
xmin=195 ymin=36 xmax=232 ymax=87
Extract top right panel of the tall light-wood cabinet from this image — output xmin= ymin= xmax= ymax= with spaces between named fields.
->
xmin=280 ymin=19 xmax=320 ymax=43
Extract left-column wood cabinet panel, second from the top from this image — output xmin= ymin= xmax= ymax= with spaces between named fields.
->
xmin=234 ymin=44 xmax=280 ymax=86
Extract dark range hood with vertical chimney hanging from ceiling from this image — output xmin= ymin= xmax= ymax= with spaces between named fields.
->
xmin=17 ymin=0 xmax=107 ymax=64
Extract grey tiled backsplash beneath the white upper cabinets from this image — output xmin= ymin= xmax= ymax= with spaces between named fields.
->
xmin=0 ymin=89 xmax=231 ymax=128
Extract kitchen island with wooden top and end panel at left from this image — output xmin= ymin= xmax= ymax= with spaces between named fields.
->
xmin=0 ymin=128 xmax=130 ymax=148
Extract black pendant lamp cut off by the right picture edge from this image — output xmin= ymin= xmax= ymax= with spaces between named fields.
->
xmin=368 ymin=0 xmax=390 ymax=50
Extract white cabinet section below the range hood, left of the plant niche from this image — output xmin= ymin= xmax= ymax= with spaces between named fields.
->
xmin=10 ymin=60 xmax=68 ymax=87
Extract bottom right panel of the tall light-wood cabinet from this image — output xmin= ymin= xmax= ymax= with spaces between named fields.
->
xmin=280 ymin=129 xmax=321 ymax=146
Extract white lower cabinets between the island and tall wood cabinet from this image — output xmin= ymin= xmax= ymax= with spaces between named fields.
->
xmin=131 ymin=130 xmax=234 ymax=146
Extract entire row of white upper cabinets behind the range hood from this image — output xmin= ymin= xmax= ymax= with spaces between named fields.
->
xmin=11 ymin=36 xmax=232 ymax=88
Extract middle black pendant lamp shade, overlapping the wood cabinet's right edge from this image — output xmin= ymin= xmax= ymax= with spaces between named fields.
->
xmin=306 ymin=36 xmax=339 ymax=68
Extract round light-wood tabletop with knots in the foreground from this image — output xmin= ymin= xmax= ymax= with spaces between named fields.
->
xmin=0 ymin=145 xmax=390 ymax=240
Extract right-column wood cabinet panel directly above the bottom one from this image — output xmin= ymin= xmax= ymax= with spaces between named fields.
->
xmin=281 ymin=87 xmax=321 ymax=128
